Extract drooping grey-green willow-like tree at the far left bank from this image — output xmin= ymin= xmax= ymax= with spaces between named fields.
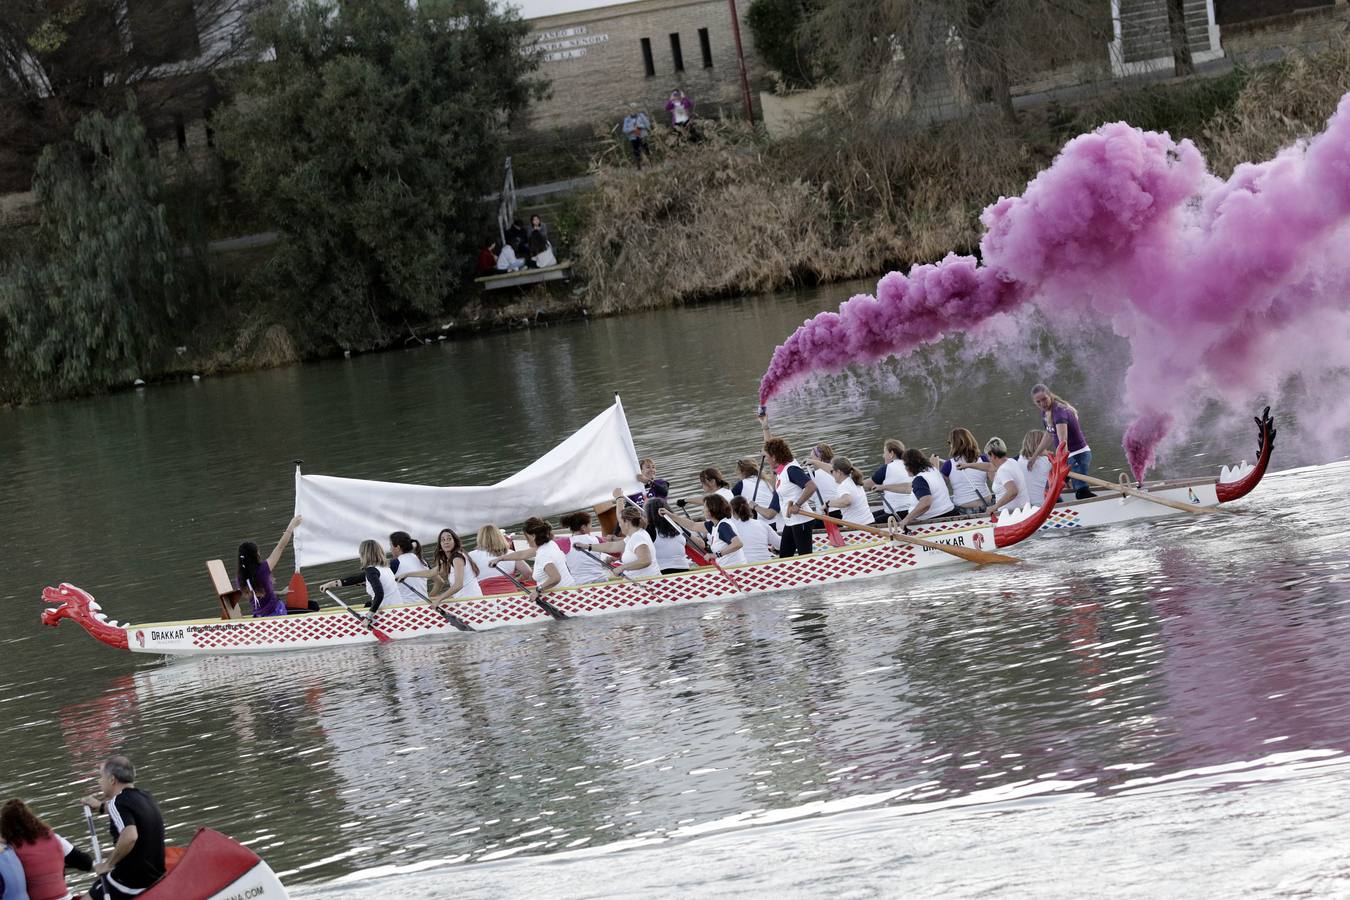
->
xmin=0 ymin=107 xmax=180 ymax=397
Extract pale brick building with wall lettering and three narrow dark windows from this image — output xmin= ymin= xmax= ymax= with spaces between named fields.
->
xmin=529 ymin=0 xmax=764 ymax=130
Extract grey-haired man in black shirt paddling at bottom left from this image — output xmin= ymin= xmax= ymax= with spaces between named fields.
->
xmin=80 ymin=756 xmax=165 ymax=900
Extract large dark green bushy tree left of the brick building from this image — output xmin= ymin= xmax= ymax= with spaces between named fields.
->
xmin=217 ymin=0 xmax=540 ymax=348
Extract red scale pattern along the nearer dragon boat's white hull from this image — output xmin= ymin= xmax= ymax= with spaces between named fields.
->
xmin=176 ymin=541 xmax=950 ymax=652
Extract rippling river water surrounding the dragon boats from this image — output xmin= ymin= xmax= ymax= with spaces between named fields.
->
xmin=0 ymin=279 xmax=1350 ymax=897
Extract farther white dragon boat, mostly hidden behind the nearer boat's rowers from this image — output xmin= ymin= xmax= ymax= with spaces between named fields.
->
xmin=814 ymin=406 xmax=1276 ymax=549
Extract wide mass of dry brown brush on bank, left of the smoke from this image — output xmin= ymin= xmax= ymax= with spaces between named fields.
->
xmin=576 ymin=111 xmax=1035 ymax=312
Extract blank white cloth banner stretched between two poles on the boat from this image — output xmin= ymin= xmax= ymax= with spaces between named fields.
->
xmin=294 ymin=397 xmax=641 ymax=568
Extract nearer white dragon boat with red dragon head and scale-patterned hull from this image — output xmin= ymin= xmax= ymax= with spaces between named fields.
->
xmin=42 ymin=452 xmax=1068 ymax=656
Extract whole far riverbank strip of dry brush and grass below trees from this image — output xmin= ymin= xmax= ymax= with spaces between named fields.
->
xmin=0 ymin=42 xmax=1350 ymax=403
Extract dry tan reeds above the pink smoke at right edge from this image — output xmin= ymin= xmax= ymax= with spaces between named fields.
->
xmin=1202 ymin=36 xmax=1350 ymax=177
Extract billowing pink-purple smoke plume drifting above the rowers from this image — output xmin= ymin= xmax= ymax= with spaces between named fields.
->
xmin=760 ymin=94 xmax=1350 ymax=479
